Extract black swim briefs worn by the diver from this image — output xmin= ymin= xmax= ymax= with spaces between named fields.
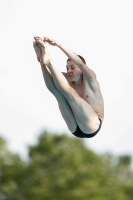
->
xmin=73 ymin=118 xmax=102 ymax=138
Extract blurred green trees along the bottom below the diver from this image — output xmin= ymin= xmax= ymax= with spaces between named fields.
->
xmin=0 ymin=131 xmax=133 ymax=200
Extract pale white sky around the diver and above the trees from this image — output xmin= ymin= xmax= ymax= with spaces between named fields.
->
xmin=0 ymin=0 xmax=133 ymax=159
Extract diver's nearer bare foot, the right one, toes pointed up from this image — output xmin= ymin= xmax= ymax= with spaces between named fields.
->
xmin=34 ymin=37 xmax=50 ymax=64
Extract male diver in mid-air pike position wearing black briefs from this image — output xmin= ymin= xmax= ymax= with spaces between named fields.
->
xmin=33 ymin=36 xmax=104 ymax=138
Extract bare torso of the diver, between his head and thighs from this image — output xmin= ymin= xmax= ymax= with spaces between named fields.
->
xmin=63 ymin=72 xmax=104 ymax=121
